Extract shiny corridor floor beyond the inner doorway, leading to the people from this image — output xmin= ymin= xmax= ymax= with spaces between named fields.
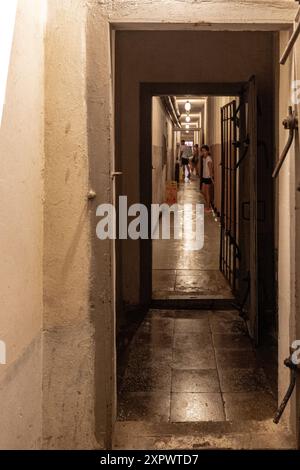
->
xmin=152 ymin=178 xmax=233 ymax=299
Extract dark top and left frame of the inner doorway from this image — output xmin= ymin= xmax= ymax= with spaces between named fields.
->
xmin=139 ymin=82 xmax=247 ymax=308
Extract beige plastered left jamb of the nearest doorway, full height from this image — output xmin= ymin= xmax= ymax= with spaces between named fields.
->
xmin=86 ymin=2 xmax=116 ymax=447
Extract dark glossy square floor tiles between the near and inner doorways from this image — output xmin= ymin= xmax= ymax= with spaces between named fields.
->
xmin=118 ymin=310 xmax=276 ymax=423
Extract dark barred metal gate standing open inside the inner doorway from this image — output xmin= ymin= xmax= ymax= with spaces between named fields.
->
xmin=220 ymin=100 xmax=239 ymax=292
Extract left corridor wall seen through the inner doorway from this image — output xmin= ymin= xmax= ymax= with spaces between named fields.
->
xmin=152 ymin=96 xmax=174 ymax=204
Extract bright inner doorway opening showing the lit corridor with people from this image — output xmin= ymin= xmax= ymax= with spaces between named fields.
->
xmin=152 ymin=95 xmax=239 ymax=305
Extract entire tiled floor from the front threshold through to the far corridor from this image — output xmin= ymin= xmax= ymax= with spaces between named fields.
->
xmin=113 ymin=180 xmax=288 ymax=449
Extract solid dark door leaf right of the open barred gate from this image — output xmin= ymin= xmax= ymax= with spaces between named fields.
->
xmin=237 ymin=77 xmax=259 ymax=345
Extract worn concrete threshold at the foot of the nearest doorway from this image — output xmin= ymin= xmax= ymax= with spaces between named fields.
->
xmin=113 ymin=420 xmax=296 ymax=450
